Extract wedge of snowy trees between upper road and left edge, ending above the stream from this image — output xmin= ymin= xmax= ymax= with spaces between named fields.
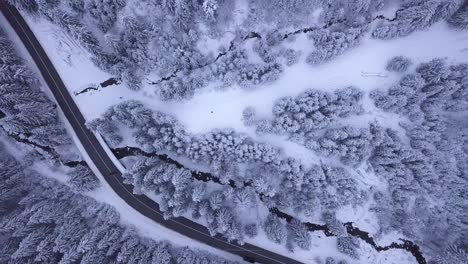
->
xmin=0 ymin=30 xmax=71 ymax=158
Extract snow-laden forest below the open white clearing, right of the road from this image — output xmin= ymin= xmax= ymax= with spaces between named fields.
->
xmin=89 ymin=59 xmax=468 ymax=260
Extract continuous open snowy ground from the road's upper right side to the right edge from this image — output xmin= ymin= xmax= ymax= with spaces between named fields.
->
xmin=22 ymin=13 xmax=468 ymax=135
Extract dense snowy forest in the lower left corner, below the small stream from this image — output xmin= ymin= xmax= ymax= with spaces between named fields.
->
xmin=0 ymin=146 xmax=233 ymax=264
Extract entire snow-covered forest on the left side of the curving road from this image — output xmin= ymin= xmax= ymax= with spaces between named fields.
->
xmin=0 ymin=22 xmax=235 ymax=264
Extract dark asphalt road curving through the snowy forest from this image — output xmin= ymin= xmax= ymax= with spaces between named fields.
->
xmin=0 ymin=3 xmax=301 ymax=264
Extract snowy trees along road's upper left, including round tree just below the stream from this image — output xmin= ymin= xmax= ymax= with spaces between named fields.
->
xmin=0 ymin=26 xmax=99 ymax=191
